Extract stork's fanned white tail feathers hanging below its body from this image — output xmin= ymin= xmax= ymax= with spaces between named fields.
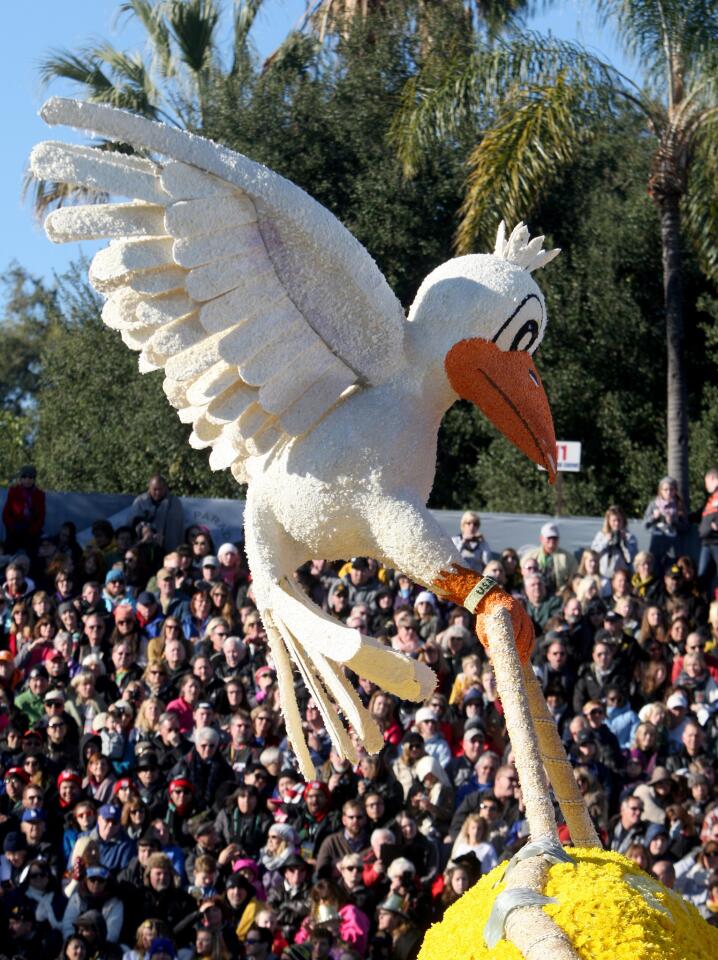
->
xmin=263 ymin=580 xmax=436 ymax=779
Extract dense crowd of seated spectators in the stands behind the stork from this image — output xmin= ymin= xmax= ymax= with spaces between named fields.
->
xmin=0 ymin=467 xmax=718 ymax=960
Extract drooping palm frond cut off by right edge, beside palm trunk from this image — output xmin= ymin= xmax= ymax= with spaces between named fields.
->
xmin=682 ymin=113 xmax=718 ymax=282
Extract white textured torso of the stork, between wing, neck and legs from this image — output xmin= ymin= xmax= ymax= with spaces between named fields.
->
xmin=245 ymin=350 xmax=459 ymax=589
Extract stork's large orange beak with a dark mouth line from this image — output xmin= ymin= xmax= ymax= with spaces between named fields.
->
xmin=444 ymin=337 xmax=556 ymax=483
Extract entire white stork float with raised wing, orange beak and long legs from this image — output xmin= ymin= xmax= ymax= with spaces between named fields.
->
xmin=31 ymin=99 xmax=718 ymax=960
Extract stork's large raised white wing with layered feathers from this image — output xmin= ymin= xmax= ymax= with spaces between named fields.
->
xmin=31 ymin=98 xmax=404 ymax=480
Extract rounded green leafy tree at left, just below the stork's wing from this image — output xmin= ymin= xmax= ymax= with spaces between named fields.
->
xmin=33 ymin=265 xmax=238 ymax=497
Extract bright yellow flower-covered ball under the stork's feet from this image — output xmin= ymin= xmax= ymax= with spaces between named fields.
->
xmin=419 ymin=848 xmax=718 ymax=960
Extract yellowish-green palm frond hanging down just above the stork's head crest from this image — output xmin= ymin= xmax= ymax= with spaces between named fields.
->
xmin=456 ymin=77 xmax=596 ymax=254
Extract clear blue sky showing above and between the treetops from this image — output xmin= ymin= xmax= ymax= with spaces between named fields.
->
xmin=0 ymin=0 xmax=630 ymax=278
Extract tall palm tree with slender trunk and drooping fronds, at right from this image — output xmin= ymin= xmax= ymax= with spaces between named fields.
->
xmin=395 ymin=0 xmax=718 ymax=502
